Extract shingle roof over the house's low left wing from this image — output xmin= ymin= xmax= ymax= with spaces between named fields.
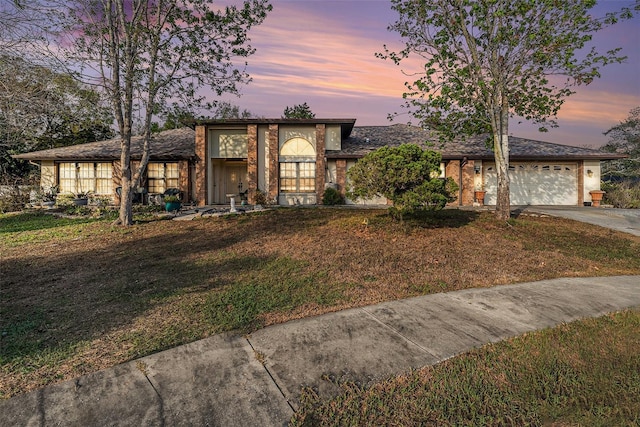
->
xmin=14 ymin=127 xmax=196 ymax=160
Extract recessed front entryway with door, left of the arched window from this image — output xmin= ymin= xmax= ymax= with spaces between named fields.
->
xmin=207 ymin=159 xmax=249 ymax=204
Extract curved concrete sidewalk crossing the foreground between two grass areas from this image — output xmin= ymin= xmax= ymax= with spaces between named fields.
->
xmin=0 ymin=276 xmax=640 ymax=426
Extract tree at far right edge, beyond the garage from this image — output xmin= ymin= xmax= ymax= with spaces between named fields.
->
xmin=602 ymin=107 xmax=640 ymax=178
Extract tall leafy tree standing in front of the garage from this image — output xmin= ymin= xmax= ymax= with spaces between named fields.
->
xmin=378 ymin=0 xmax=631 ymax=220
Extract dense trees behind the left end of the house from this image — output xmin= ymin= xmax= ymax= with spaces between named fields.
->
xmin=0 ymin=55 xmax=113 ymax=183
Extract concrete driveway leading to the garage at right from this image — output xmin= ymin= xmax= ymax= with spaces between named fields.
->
xmin=516 ymin=206 xmax=640 ymax=236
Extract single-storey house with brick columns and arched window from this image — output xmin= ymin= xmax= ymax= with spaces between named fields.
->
xmin=15 ymin=119 xmax=622 ymax=206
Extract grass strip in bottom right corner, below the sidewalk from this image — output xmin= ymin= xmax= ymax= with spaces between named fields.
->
xmin=291 ymin=310 xmax=640 ymax=427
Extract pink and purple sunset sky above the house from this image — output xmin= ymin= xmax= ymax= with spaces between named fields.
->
xmin=221 ymin=0 xmax=640 ymax=147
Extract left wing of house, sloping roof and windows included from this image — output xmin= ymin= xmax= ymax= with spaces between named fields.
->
xmin=13 ymin=128 xmax=195 ymax=202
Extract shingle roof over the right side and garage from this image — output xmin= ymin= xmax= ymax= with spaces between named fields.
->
xmin=326 ymin=124 xmax=624 ymax=160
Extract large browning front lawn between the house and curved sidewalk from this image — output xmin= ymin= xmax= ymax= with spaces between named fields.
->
xmin=0 ymin=208 xmax=640 ymax=398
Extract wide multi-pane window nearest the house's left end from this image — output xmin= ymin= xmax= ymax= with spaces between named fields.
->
xmin=58 ymin=162 xmax=113 ymax=194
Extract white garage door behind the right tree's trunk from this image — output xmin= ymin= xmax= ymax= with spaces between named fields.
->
xmin=483 ymin=163 xmax=578 ymax=206
